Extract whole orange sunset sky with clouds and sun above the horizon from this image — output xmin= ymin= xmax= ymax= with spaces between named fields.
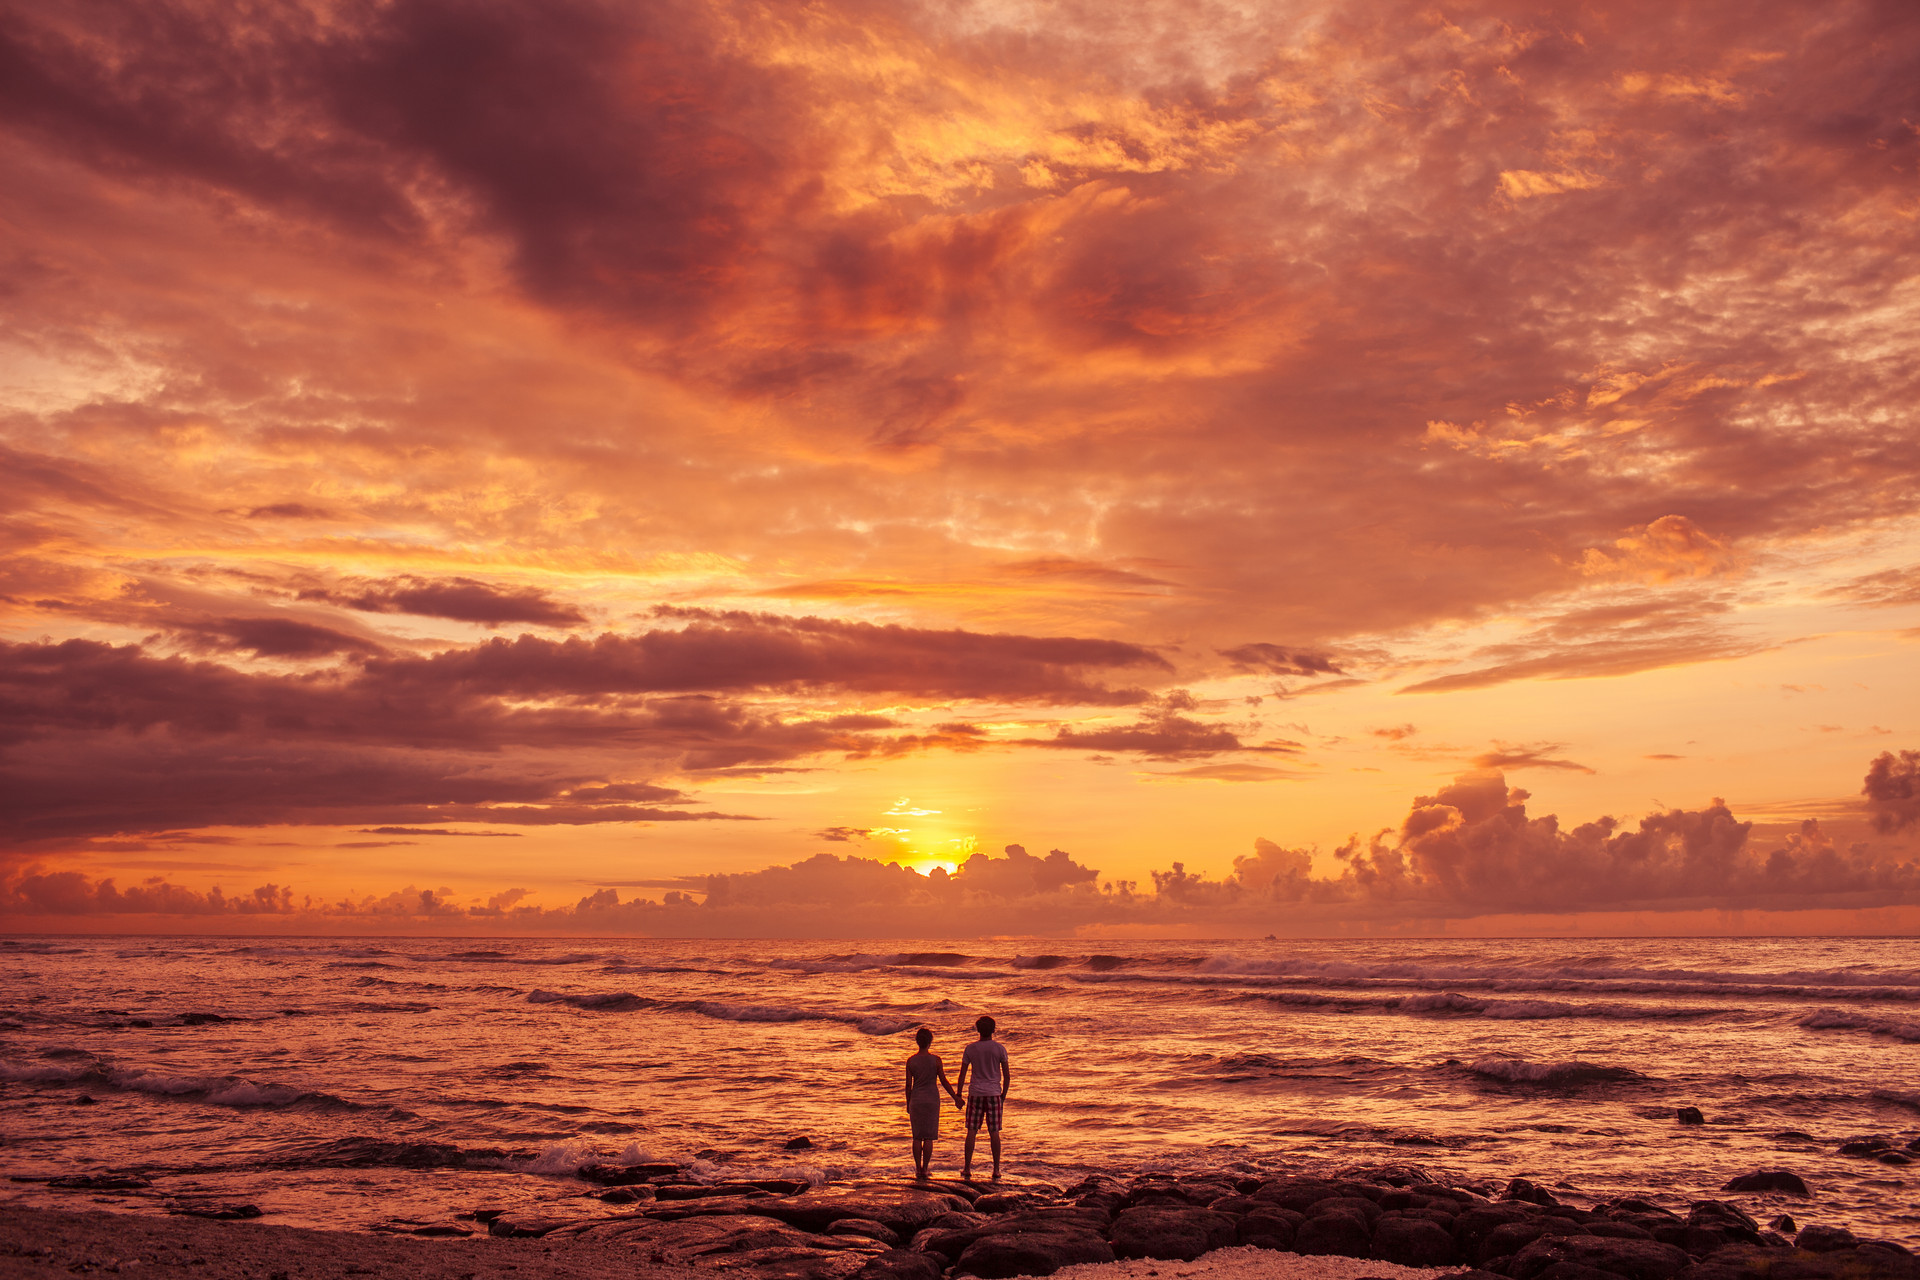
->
xmin=0 ymin=0 xmax=1920 ymax=936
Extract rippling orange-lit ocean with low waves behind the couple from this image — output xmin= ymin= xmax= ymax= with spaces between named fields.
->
xmin=0 ymin=936 xmax=1920 ymax=1245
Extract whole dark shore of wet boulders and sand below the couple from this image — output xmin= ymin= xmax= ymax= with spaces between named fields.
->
xmin=0 ymin=1165 xmax=1920 ymax=1280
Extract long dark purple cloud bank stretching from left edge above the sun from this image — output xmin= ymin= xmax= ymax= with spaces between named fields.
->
xmin=0 ymin=614 xmax=1182 ymax=844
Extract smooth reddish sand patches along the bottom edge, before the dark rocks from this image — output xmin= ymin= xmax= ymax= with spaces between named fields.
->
xmin=0 ymin=1205 xmax=1457 ymax=1280
